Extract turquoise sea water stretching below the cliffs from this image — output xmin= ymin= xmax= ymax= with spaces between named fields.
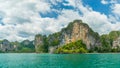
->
xmin=0 ymin=53 xmax=120 ymax=68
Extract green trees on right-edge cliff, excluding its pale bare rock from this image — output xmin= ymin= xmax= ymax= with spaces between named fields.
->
xmin=99 ymin=31 xmax=120 ymax=52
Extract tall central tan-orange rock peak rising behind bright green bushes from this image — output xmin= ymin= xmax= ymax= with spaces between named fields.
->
xmin=61 ymin=20 xmax=99 ymax=49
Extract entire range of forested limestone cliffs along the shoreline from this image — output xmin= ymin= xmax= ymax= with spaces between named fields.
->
xmin=0 ymin=20 xmax=120 ymax=53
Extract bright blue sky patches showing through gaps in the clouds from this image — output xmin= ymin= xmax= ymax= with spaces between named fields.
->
xmin=40 ymin=0 xmax=112 ymax=18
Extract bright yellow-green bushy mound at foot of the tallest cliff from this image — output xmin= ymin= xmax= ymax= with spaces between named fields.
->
xmin=56 ymin=40 xmax=88 ymax=53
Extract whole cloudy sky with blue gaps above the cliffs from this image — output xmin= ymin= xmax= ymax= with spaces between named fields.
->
xmin=0 ymin=0 xmax=120 ymax=41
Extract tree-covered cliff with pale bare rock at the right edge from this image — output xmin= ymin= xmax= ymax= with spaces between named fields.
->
xmin=101 ymin=31 xmax=120 ymax=52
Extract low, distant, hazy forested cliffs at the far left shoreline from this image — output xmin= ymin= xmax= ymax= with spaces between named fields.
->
xmin=0 ymin=39 xmax=35 ymax=53
